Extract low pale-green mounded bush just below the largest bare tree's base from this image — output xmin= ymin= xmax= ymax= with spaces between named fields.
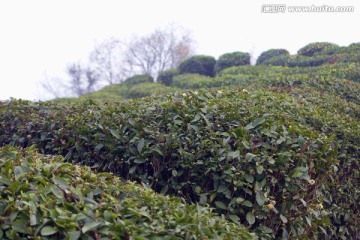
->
xmin=127 ymin=83 xmax=169 ymax=98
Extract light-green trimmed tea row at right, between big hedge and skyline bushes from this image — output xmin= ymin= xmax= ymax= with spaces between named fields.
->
xmin=219 ymin=63 xmax=360 ymax=104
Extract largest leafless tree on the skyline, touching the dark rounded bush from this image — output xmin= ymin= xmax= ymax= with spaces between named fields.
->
xmin=124 ymin=25 xmax=194 ymax=77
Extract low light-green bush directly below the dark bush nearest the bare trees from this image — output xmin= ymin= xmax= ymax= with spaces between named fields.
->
xmin=173 ymin=74 xmax=215 ymax=89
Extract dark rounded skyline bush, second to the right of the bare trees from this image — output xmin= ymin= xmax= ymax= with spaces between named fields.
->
xmin=215 ymin=52 xmax=250 ymax=73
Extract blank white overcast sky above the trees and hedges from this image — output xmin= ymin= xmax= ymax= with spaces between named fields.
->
xmin=0 ymin=0 xmax=360 ymax=100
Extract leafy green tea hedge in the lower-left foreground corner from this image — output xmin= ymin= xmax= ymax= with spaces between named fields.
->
xmin=0 ymin=147 xmax=254 ymax=240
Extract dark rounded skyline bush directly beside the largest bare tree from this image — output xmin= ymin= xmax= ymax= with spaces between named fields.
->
xmin=179 ymin=55 xmax=216 ymax=77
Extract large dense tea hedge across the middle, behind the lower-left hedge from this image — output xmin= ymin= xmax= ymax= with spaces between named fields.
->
xmin=0 ymin=86 xmax=360 ymax=239
